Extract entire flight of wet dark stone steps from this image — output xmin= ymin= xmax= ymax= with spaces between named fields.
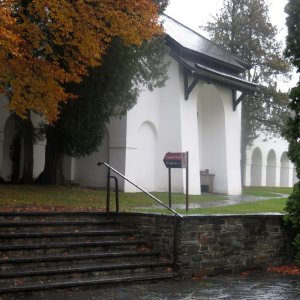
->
xmin=0 ymin=212 xmax=174 ymax=298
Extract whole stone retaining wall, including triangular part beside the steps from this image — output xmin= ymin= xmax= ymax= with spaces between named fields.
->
xmin=111 ymin=213 xmax=293 ymax=278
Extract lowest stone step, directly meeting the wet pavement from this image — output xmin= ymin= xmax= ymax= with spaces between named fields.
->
xmin=0 ymin=272 xmax=175 ymax=299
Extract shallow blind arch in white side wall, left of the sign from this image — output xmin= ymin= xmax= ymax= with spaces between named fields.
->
xmin=137 ymin=121 xmax=158 ymax=191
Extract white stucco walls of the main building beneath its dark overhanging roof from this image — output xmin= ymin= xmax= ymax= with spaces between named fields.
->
xmin=125 ymin=59 xmax=241 ymax=195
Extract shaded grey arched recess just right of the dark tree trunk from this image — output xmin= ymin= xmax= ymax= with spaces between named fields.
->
xmin=74 ymin=128 xmax=109 ymax=187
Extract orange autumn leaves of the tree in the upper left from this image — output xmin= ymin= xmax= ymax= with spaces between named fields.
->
xmin=0 ymin=0 xmax=161 ymax=123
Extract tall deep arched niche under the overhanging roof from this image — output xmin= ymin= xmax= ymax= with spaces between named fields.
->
xmin=197 ymin=84 xmax=228 ymax=193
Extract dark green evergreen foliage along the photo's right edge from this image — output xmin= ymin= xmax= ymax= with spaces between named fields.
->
xmin=283 ymin=0 xmax=300 ymax=265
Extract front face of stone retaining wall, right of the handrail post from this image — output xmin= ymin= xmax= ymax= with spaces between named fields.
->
xmin=178 ymin=215 xmax=292 ymax=277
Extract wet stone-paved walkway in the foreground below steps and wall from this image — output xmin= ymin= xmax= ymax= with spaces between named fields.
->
xmin=6 ymin=272 xmax=300 ymax=300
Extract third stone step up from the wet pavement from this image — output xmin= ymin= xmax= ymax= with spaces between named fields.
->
xmin=0 ymin=250 xmax=160 ymax=272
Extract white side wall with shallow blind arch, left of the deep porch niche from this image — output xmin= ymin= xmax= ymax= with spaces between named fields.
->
xmin=125 ymin=56 xmax=183 ymax=192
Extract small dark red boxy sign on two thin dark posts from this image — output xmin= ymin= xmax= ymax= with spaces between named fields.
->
xmin=163 ymin=151 xmax=189 ymax=210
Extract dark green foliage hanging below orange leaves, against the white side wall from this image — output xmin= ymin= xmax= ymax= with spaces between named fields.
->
xmin=46 ymin=37 xmax=167 ymax=156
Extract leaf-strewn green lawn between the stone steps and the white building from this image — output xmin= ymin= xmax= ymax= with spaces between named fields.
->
xmin=0 ymin=184 xmax=292 ymax=214
